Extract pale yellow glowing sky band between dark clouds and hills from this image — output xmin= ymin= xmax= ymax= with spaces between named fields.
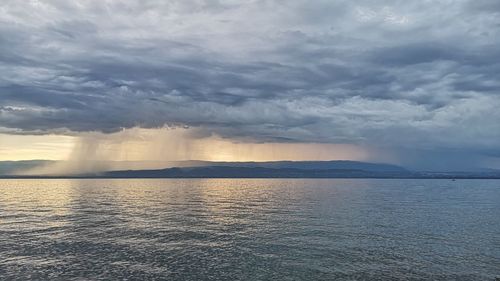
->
xmin=0 ymin=128 xmax=376 ymax=162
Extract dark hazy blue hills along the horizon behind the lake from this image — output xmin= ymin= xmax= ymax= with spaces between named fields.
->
xmin=0 ymin=160 xmax=500 ymax=178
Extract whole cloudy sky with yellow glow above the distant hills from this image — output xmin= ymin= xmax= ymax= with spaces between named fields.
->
xmin=0 ymin=0 xmax=500 ymax=170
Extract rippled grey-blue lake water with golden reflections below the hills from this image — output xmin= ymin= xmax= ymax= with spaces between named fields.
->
xmin=0 ymin=179 xmax=500 ymax=280
